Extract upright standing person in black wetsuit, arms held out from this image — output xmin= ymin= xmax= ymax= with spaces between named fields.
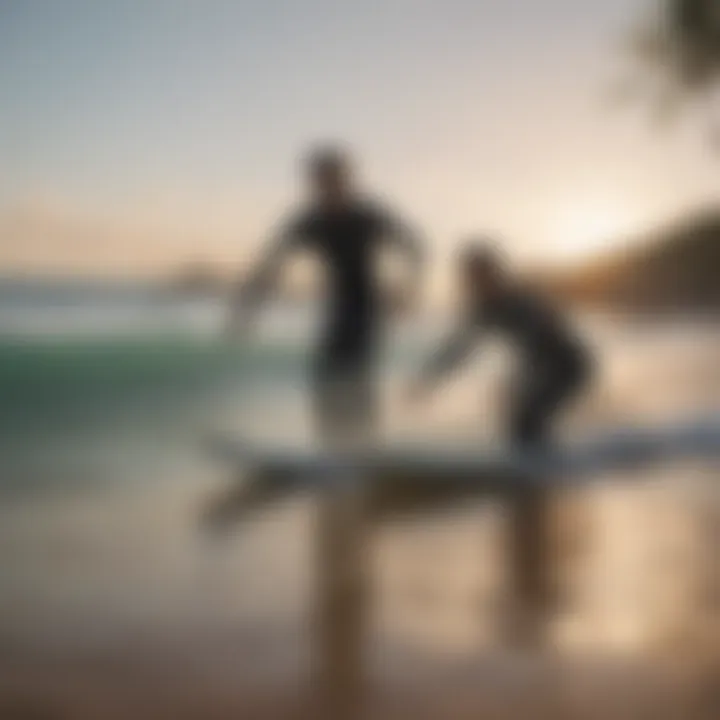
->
xmin=229 ymin=148 xmax=423 ymax=439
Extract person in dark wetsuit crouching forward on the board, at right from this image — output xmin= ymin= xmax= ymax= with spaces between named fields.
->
xmin=412 ymin=242 xmax=592 ymax=448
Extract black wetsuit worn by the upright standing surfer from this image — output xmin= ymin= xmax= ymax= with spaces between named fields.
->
xmin=286 ymin=201 xmax=418 ymax=432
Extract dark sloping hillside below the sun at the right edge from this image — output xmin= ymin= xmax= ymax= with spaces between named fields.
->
xmin=549 ymin=210 xmax=720 ymax=311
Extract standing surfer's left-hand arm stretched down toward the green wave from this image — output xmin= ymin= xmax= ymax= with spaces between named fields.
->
xmin=228 ymin=228 xmax=300 ymax=335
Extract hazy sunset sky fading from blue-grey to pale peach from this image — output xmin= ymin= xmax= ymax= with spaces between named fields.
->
xmin=0 ymin=0 xmax=720 ymax=274
